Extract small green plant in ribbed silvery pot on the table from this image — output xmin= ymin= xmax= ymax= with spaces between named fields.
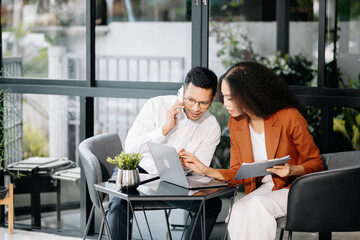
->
xmin=106 ymin=152 xmax=143 ymax=190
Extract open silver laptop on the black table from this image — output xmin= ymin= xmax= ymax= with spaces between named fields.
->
xmin=148 ymin=142 xmax=228 ymax=189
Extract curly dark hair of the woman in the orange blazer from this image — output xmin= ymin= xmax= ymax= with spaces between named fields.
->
xmin=218 ymin=62 xmax=303 ymax=118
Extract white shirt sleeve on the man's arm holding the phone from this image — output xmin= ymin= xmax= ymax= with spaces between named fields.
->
xmin=125 ymin=99 xmax=165 ymax=153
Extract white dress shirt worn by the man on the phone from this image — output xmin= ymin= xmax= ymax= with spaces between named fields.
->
xmin=125 ymin=95 xmax=220 ymax=174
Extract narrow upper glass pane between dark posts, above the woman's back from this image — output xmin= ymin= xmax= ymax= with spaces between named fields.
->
xmin=284 ymin=0 xmax=319 ymax=86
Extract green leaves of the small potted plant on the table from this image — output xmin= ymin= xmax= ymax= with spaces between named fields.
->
xmin=106 ymin=151 xmax=143 ymax=170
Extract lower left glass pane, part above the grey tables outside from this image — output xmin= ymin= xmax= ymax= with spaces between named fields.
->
xmin=3 ymin=91 xmax=80 ymax=165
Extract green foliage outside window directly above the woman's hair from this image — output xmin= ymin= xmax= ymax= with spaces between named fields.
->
xmin=210 ymin=22 xmax=317 ymax=86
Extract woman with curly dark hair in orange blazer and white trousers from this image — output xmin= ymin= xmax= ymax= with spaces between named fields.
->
xmin=179 ymin=62 xmax=323 ymax=240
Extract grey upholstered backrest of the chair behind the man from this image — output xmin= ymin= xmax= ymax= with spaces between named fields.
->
xmin=79 ymin=133 xmax=122 ymax=207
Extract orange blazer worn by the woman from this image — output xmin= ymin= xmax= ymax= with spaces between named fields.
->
xmin=219 ymin=108 xmax=324 ymax=193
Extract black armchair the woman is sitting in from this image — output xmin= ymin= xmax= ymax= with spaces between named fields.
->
xmin=277 ymin=151 xmax=360 ymax=240
